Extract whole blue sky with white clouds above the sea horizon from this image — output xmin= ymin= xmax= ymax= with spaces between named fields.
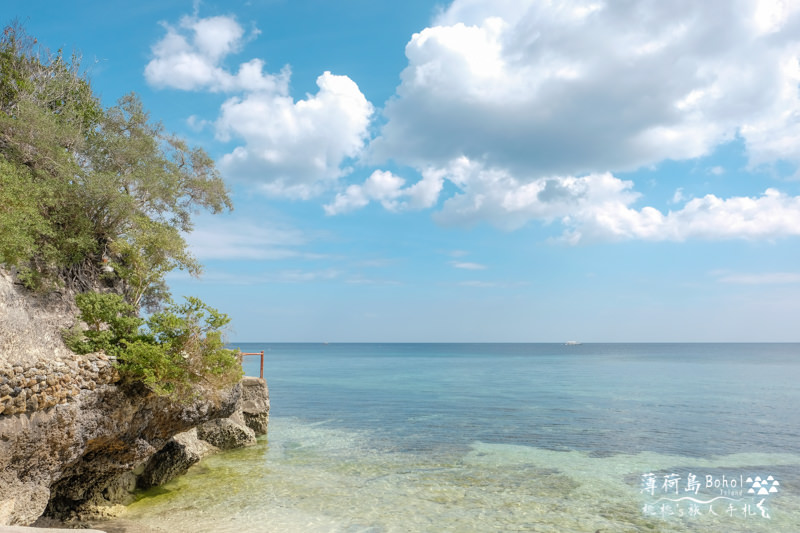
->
xmin=7 ymin=0 xmax=800 ymax=342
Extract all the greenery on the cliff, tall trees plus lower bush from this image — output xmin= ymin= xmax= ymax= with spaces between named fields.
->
xmin=0 ymin=25 xmax=241 ymax=399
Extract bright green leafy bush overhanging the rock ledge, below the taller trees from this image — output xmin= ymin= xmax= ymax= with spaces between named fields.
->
xmin=64 ymin=292 xmax=242 ymax=400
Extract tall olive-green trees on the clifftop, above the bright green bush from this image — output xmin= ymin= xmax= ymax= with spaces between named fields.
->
xmin=0 ymin=25 xmax=232 ymax=304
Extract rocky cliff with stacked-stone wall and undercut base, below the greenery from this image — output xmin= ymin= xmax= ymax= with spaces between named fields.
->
xmin=0 ymin=269 xmax=269 ymax=525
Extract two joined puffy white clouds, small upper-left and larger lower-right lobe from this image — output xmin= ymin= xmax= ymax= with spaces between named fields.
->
xmin=145 ymin=16 xmax=373 ymax=198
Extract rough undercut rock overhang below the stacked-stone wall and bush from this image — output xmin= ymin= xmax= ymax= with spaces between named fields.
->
xmin=0 ymin=376 xmax=239 ymax=524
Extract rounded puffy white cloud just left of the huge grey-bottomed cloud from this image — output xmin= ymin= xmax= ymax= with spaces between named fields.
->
xmin=216 ymin=72 xmax=373 ymax=198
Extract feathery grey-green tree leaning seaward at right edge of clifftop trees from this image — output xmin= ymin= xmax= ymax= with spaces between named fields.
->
xmin=87 ymin=95 xmax=232 ymax=308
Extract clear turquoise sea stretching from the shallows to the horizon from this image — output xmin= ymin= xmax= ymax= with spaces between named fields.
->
xmin=122 ymin=343 xmax=800 ymax=533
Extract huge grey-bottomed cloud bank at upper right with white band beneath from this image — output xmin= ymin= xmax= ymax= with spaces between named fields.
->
xmin=326 ymin=0 xmax=800 ymax=243
